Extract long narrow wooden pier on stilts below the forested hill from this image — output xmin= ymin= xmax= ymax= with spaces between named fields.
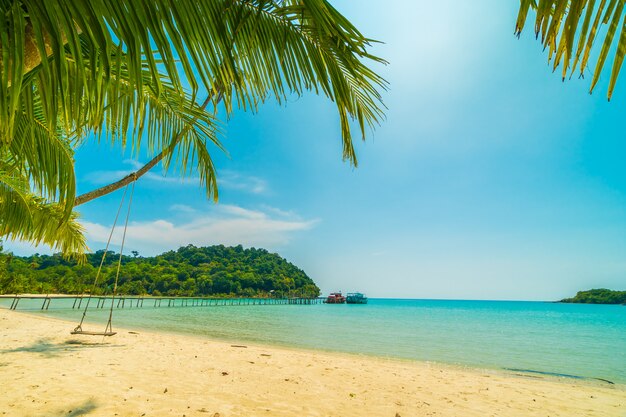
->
xmin=0 ymin=294 xmax=323 ymax=310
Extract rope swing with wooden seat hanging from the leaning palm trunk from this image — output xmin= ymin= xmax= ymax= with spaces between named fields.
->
xmin=71 ymin=179 xmax=137 ymax=336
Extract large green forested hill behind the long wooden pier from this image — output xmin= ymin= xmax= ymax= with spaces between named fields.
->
xmin=0 ymin=245 xmax=319 ymax=297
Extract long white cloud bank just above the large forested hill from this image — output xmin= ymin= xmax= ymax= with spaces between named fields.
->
xmin=82 ymin=205 xmax=317 ymax=255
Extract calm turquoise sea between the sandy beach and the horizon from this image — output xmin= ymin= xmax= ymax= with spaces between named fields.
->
xmin=0 ymin=299 xmax=626 ymax=384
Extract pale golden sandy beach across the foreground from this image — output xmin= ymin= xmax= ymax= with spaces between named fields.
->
xmin=0 ymin=310 xmax=626 ymax=417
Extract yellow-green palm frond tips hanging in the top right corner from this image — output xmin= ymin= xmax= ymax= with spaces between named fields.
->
xmin=515 ymin=0 xmax=626 ymax=100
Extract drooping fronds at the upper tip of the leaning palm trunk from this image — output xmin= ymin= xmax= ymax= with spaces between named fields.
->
xmin=92 ymin=46 xmax=226 ymax=200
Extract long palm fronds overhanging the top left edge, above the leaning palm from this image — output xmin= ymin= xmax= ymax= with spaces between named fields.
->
xmin=0 ymin=0 xmax=385 ymax=163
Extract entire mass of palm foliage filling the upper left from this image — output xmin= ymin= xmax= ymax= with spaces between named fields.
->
xmin=0 ymin=0 xmax=386 ymax=252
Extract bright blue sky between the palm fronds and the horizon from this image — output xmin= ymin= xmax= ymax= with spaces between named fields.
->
xmin=6 ymin=0 xmax=626 ymax=300
